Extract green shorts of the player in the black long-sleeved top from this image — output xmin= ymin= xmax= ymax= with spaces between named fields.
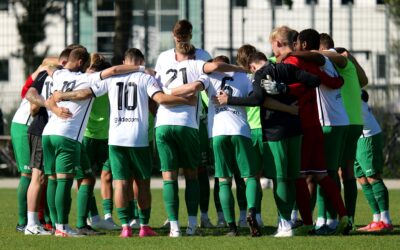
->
xmin=264 ymin=135 xmax=301 ymax=180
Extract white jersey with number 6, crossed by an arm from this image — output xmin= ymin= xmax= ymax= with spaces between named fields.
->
xmin=206 ymin=72 xmax=253 ymax=138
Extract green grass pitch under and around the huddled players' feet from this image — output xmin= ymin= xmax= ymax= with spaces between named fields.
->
xmin=0 ymin=189 xmax=400 ymax=250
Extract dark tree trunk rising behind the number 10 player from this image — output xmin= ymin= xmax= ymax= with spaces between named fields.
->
xmin=112 ymin=0 xmax=133 ymax=65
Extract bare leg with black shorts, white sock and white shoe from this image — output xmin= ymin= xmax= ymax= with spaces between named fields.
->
xmin=25 ymin=135 xmax=51 ymax=235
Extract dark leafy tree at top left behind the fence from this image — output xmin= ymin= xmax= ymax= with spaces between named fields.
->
xmin=12 ymin=0 xmax=61 ymax=76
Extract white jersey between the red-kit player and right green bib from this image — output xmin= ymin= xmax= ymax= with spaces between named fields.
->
xmin=316 ymin=57 xmax=349 ymax=126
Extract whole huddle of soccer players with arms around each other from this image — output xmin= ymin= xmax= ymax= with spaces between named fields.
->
xmin=11 ymin=20 xmax=393 ymax=237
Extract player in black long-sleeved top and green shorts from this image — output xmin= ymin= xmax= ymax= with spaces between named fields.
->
xmin=215 ymin=55 xmax=320 ymax=237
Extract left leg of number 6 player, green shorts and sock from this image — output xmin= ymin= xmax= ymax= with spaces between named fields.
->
xmin=212 ymin=136 xmax=238 ymax=236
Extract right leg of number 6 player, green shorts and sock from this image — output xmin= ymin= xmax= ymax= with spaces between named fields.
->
xmin=231 ymin=136 xmax=261 ymax=237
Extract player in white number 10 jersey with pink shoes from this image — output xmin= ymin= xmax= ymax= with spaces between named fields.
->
xmin=51 ymin=48 xmax=195 ymax=237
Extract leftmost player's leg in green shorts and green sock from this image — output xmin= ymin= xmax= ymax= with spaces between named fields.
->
xmin=11 ymin=122 xmax=31 ymax=232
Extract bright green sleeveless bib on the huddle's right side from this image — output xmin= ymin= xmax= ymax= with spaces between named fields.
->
xmin=337 ymin=60 xmax=363 ymax=125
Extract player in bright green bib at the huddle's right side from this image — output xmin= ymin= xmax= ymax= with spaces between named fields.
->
xmin=320 ymin=33 xmax=368 ymax=229
